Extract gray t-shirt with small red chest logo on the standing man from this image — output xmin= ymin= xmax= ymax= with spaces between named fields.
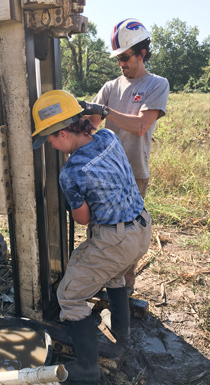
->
xmin=93 ymin=73 xmax=169 ymax=179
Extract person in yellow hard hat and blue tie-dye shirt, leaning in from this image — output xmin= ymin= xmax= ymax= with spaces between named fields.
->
xmin=32 ymin=90 xmax=151 ymax=383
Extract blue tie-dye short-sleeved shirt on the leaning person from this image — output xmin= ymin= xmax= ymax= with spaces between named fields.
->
xmin=60 ymin=129 xmax=144 ymax=224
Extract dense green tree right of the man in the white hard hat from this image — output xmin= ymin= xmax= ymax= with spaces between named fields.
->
xmin=151 ymin=19 xmax=209 ymax=91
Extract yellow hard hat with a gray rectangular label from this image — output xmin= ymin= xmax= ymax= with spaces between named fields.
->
xmin=32 ymin=90 xmax=83 ymax=136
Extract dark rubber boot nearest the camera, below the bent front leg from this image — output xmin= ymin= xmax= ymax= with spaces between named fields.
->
xmin=65 ymin=315 xmax=101 ymax=383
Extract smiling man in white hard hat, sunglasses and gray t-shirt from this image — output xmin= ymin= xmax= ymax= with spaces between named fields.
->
xmin=81 ymin=19 xmax=169 ymax=293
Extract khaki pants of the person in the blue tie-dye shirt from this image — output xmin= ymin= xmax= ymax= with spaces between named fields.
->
xmin=57 ymin=210 xmax=151 ymax=321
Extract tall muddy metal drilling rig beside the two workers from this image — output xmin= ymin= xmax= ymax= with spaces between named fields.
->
xmin=0 ymin=0 xmax=88 ymax=321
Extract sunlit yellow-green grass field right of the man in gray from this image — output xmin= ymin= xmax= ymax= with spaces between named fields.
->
xmin=145 ymin=93 xmax=210 ymax=240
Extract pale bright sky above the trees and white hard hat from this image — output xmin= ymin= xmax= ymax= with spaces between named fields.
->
xmin=82 ymin=0 xmax=210 ymax=49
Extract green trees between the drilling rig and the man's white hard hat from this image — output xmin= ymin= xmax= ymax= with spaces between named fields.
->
xmin=61 ymin=22 xmax=120 ymax=96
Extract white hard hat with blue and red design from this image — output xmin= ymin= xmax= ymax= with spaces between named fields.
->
xmin=110 ymin=19 xmax=150 ymax=57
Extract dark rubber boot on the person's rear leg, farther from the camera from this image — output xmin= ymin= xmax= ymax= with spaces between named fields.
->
xmin=101 ymin=286 xmax=130 ymax=346
